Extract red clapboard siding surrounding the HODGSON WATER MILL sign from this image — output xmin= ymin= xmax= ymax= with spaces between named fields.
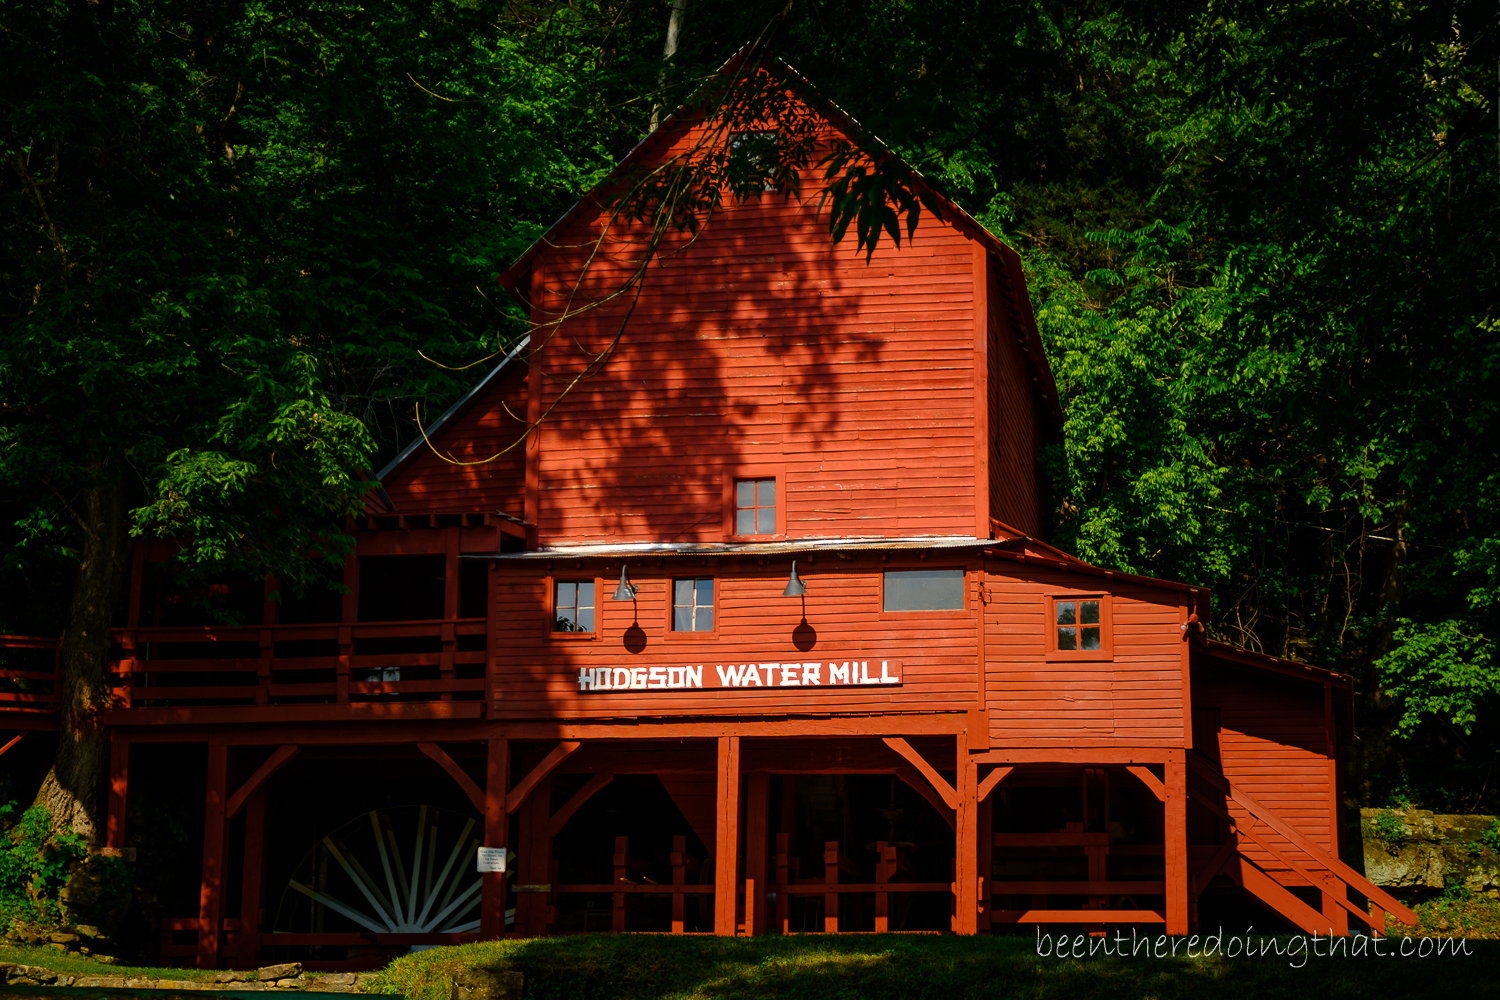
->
xmin=491 ymin=558 xmax=978 ymax=718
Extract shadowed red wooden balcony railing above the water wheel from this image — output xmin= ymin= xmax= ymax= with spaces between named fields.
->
xmin=113 ymin=618 xmax=488 ymax=708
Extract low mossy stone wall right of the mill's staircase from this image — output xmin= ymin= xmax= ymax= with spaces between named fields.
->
xmin=1359 ymin=810 xmax=1500 ymax=897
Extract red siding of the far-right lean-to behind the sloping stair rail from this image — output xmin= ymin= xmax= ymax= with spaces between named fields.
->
xmin=1193 ymin=660 xmax=1337 ymax=868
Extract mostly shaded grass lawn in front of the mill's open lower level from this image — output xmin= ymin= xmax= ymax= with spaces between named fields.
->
xmin=366 ymin=934 xmax=1500 ymax=1000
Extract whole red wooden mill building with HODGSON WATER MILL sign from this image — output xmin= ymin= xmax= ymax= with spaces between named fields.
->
xmin=0 ymin=60 xmax=1415 ymax=967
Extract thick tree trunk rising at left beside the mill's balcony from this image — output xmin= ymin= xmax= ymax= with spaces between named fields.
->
xmin=36 ymin=469 xmax=131 ymax=847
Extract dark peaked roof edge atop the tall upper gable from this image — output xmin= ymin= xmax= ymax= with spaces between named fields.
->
xmin=497 ymin=46 xmax=1064 ymax=427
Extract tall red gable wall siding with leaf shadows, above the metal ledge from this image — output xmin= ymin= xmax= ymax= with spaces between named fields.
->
xmin=516 ymin=118 xmax=978 ymax=544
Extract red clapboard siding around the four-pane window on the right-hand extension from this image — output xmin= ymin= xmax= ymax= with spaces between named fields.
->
xmin=986 ymin=567 xmax=1182 ymax=747
